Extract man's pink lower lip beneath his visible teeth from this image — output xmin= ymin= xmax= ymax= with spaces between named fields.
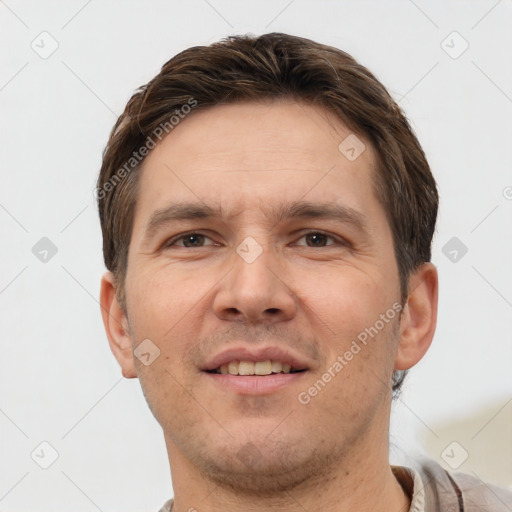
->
xmin=204 ymin=371 xmax=307 ymax=395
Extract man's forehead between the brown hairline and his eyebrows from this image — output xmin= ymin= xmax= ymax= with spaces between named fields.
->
xmin=134 ymin=101 xmax=383 ymax=232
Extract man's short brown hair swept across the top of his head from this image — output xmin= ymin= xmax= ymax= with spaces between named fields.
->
xmin=97 ymin=33 xmax=439 ymax=391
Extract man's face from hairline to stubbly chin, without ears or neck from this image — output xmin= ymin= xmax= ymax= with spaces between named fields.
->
xmin=119 ymin=102 xmax=400 ymax=490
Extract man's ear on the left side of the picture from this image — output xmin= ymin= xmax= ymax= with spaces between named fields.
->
xmin=100 ymin=272 xmax=137 ymax=379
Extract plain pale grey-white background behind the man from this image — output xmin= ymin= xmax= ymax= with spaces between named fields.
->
xmin=0 ymin=0 xmax=512 ymax=512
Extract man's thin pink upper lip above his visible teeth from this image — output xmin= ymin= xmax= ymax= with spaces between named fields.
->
xmin=201 ymin=346 xmax=309 ymax=371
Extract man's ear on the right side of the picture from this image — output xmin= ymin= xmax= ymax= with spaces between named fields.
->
xmin=395 ymin=263 xmax=438 ymax=370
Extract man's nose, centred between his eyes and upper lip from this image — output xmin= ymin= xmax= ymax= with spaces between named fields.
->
xmin=213 ymin=239 xmax=297 ymax=324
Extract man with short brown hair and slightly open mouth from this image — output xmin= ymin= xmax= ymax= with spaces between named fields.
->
xmin=97 ymin=33 xmax=512 ymax=512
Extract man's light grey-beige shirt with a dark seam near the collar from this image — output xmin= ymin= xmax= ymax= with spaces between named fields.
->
xmin=159 ymin=459 xmax=512 ymax=512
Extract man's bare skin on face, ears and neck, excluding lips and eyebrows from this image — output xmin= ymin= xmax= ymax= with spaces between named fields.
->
xmin=101 ymin=101 xmax=438 ymax=512
